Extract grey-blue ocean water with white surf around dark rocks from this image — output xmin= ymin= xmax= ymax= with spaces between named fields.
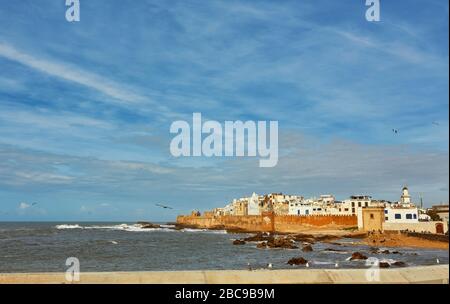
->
xmin=0 ymin=222 xmax=449 ymax=273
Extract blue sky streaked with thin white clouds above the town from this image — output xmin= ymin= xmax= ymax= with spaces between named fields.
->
xmin=0 ymin=0 xmax=449 ymax=221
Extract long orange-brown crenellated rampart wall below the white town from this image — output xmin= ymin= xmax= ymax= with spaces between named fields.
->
xmin=177 ymin=212 xmax=357 ymax=232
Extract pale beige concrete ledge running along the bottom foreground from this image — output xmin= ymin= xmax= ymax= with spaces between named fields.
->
xmin=0 ymin=265 xmax=449 ymax=284
